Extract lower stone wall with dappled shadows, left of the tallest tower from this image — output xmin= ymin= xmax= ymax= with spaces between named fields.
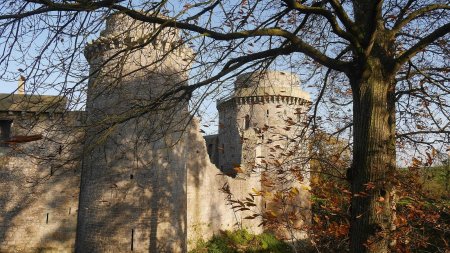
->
xmin=0 ymin=111 xmax=83 ymax=252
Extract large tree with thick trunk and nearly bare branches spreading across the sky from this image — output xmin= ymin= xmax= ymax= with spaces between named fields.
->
xmin=0 ymin=0 xmax=450 ymax=252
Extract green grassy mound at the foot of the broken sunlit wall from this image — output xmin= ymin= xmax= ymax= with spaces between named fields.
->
xmin=190 ymin=230 xmax=292 ymax=253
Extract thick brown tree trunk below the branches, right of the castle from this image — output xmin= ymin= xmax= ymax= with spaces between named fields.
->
xmin=350 ymin=59 xmax=396 ymax=253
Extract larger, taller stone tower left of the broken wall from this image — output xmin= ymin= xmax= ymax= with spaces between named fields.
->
xmin=76 ymin=14 xmax=191 ymax=253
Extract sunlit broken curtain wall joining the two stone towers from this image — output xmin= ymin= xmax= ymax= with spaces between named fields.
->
xmin=186 ymin=120 xmax=263 ymax=249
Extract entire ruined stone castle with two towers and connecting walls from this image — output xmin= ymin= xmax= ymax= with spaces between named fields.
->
xmin=0 ymin=15 xmax=310 ymax=252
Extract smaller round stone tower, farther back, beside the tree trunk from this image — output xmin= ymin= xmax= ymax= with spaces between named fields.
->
xmin=215 ymin=71 xmax=310 ymax=239
